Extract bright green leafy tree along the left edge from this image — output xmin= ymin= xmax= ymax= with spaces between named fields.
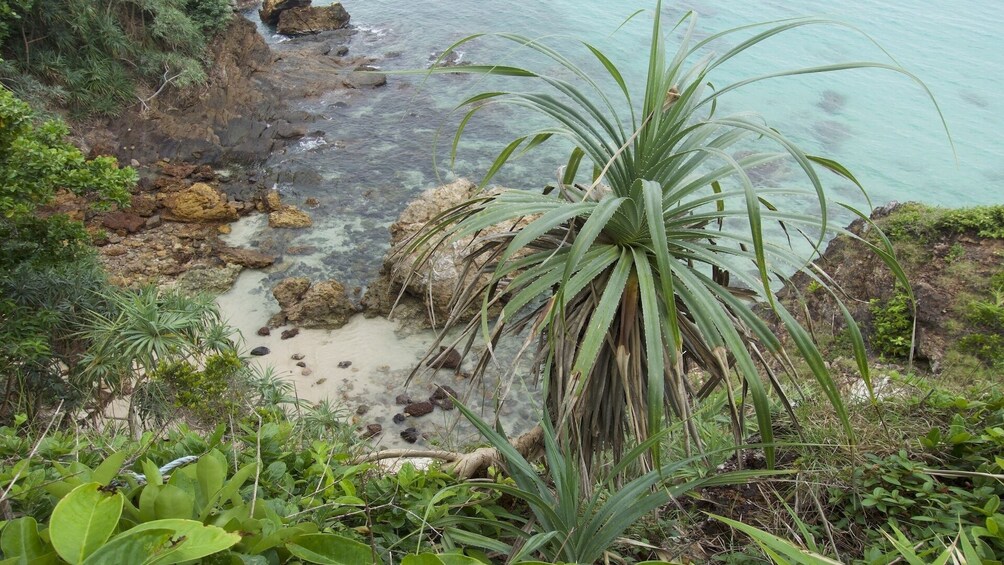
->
xmin=0 ymin=88 xmax=136 ymax=419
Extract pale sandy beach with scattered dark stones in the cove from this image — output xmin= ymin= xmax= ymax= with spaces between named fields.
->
xmin=217 ymin=268 xmax=535 ymax=449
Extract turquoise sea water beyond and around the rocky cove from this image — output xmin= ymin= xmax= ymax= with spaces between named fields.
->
xmin=250 ymin=0 xmax=1004 ymax=285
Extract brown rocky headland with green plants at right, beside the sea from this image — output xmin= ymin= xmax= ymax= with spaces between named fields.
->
xmin=780 ymin=203 xmax=1004 ymax=372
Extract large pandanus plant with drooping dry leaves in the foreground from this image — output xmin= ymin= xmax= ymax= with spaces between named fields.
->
xmin=411 ymin=2 xmax=933 ymax=472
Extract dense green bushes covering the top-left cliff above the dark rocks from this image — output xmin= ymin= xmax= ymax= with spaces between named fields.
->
xmin=0 ymin=0 xmax=233 ymax=114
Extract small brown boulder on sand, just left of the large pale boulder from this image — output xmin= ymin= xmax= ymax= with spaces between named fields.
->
xmin=269 ymin=277 xmax=356 ymax=329
